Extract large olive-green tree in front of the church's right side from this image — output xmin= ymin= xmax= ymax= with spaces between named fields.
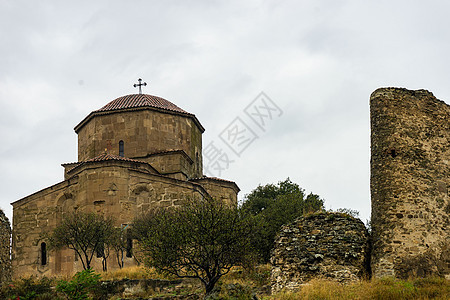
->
xmin=133 ymin=200 xmax=253 ymax=294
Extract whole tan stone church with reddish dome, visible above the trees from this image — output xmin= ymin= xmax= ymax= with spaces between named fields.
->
xmin=12 ymin=88 xmax=239 ymax=277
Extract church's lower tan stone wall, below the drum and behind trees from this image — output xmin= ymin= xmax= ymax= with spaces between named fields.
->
xmin=12 ymin=161 xmax=208 ymax=278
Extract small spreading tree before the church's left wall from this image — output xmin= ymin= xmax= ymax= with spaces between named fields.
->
xmin=48 ymin=212 xmax=115 ymax=270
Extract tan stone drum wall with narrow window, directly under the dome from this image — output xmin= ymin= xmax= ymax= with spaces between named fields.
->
xmin=77 ymin=110 xmax=203 ymax=178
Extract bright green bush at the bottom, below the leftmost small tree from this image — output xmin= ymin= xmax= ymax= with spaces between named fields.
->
xmin=56 ymin=269 xmax=100 ymax=300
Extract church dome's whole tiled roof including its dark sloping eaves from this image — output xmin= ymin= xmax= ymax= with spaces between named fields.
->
xmin=75 ymin=94 xmax=205 ymax=133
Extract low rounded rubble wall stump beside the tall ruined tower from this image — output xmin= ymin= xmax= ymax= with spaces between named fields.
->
xmin=271 ymin=212 xmax=369 ymax=293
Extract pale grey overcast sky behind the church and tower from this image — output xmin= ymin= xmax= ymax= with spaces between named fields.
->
xmin=0 ymin=0 xmax=450 ymax=225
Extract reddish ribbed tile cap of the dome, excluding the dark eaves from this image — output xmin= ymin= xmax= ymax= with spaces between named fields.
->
xmin=96 ymin=94 xmax=189 ymax=114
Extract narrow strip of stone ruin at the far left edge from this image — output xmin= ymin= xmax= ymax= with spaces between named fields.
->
xmin=0 ymin=209 xmax=11 ymax=284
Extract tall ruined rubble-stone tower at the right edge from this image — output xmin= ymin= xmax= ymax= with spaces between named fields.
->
xmin=370 ymin=88 xmax=450 ymax=278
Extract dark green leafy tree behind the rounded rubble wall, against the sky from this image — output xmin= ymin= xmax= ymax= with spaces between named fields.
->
xmin=241 ymin=178 xmax=324 ymax=262
